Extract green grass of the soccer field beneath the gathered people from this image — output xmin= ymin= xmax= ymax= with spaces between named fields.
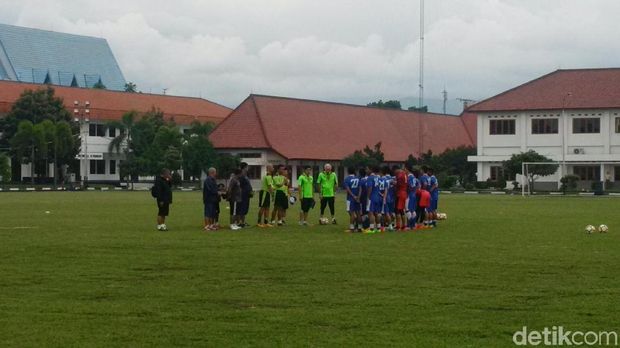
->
xmin=0 ymin=192 xmax=620 ymax=347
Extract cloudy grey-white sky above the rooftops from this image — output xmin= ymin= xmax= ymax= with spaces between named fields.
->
xmin=0 ymin=0 xmax=620 ymax=112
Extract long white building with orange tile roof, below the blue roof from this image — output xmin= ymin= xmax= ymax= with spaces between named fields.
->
xmin=0 ymin=80 xmax=231 ymax=184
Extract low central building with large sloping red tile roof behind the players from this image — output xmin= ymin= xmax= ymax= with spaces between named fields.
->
xmin=211 ymin=94 xmax=476 ymax=186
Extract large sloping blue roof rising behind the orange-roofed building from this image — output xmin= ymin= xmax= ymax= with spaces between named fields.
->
xmin=0 ymin=23 xmax=126 ymax=91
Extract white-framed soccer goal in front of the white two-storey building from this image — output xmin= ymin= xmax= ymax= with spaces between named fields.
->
xmin=517 ymin=161 xmax=620 ymax=196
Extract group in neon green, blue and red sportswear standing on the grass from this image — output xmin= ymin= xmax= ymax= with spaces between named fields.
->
xmin=253 ymin=164 xmax=439 ymax=233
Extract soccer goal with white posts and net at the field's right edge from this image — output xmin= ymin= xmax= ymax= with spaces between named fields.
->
xmin=518 ymin=161 xmax=620 ymax=197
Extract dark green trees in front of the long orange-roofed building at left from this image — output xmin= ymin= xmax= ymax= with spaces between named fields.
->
xmin=0 ymin=86 xmax=240 ymax=184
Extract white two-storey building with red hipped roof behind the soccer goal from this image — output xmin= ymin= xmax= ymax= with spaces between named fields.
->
xmin=468 ymin=69 xmax=620 ymax=189
